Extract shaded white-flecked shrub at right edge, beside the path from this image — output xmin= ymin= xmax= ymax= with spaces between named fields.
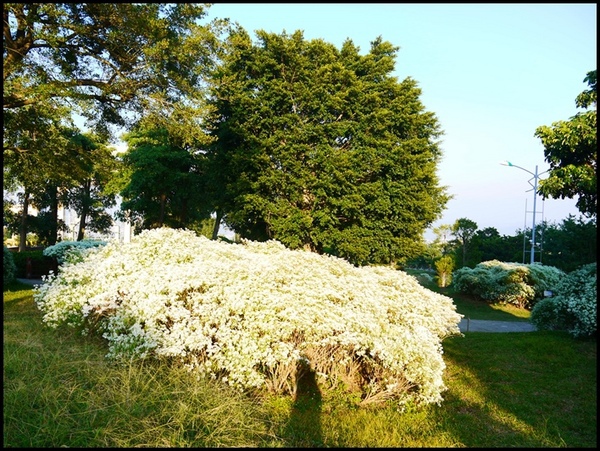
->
xmin=531 ymin=263 xmax=598 ymax=338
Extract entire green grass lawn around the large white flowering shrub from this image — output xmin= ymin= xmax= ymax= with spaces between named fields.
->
xmin=3 ymin=283 xmax=597 ymax=448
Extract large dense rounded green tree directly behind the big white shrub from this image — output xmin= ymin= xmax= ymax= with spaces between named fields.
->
xmin=207 ymin=28 xmax=449 ymax=265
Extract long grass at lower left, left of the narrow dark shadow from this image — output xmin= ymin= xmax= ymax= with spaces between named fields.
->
xmin=3 ymin=286 xmax=277 ymax=447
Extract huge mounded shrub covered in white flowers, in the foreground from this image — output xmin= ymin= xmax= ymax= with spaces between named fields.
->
xmin=34 ymin=228 xmax=462 ymax=403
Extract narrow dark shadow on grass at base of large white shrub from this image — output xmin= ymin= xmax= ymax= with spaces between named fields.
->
xmin=285 ymin=370 xmax=325 ymax=448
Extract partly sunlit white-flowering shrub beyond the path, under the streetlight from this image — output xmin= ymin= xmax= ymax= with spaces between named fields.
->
xmin=452 ymin=260 xmax=565 ymax=309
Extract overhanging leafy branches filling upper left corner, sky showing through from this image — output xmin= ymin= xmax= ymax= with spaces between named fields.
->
xmin=3 ymin=3 xmax=223 ymax=138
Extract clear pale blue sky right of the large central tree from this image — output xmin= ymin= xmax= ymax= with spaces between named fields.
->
xmin=203 ymin=3 xmax=597 ymax=238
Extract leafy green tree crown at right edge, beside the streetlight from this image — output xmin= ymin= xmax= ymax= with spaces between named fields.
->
xmin=535 ymin=70 xmax=598 ymax=218
